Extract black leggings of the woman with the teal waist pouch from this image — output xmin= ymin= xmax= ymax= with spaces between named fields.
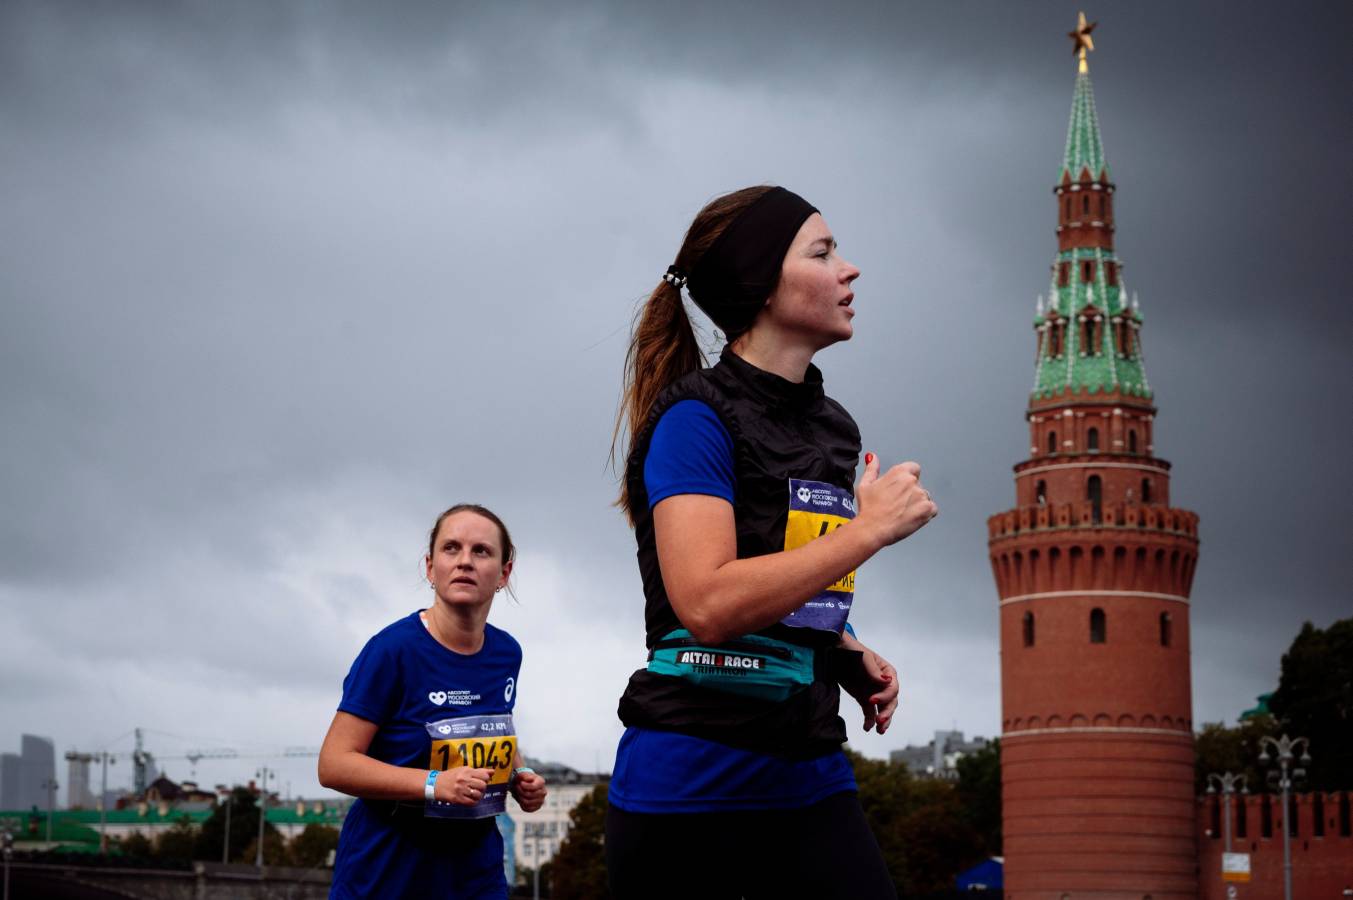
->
xmin=606 ymin=790 xmax=897 ymax=900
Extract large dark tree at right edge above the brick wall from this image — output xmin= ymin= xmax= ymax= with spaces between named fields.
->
xmin=1269 ymin=618 xmax=1353 ymax=790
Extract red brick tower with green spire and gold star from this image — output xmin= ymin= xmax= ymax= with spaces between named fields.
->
xmin=988 ymin=18 xmax=1197 ymax=900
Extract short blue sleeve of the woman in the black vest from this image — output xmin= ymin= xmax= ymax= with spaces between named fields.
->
xmin=644 ymin=401 xmax=733 ymax=509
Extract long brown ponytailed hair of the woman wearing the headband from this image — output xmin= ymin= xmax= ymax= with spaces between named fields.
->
xmin=610 ymin=184 xmax=774 ymax=524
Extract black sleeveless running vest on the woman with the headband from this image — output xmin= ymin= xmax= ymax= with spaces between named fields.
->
xmin=620 ymin=348 xmax=861 ymax=759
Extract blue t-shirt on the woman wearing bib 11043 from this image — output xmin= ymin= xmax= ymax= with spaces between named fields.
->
xmin=330 ymin=612 xmax=521 ymax=899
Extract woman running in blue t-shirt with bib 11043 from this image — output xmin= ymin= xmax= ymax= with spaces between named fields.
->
xmin=319 ymin=503 xmax=545 ymax=899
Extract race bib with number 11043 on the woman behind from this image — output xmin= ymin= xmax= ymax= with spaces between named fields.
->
xmin=423 ymin=715 xmax=517 ymax=819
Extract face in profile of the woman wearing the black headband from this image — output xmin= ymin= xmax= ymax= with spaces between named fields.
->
xmin=758 ymin=212 xmax=859 ymax=349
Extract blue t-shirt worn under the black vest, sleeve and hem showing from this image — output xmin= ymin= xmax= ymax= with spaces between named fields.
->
xmin=609 ymin=401 xmax=855 ymax=813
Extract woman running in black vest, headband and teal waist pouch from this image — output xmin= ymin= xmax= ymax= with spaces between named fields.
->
xmin=606 ymin=187 xmax=938 ymax=900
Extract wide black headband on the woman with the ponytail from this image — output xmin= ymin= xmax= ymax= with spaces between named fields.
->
xmin=686 ymin=188 xmax=817 ymax=338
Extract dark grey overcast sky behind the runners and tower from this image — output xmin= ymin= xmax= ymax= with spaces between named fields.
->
xmin=0 ymin=0 xmax=1353 ymax=794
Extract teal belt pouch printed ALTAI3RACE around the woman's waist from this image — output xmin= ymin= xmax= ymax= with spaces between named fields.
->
xmin=648 ymin=628 xmax=815 ymax=700
